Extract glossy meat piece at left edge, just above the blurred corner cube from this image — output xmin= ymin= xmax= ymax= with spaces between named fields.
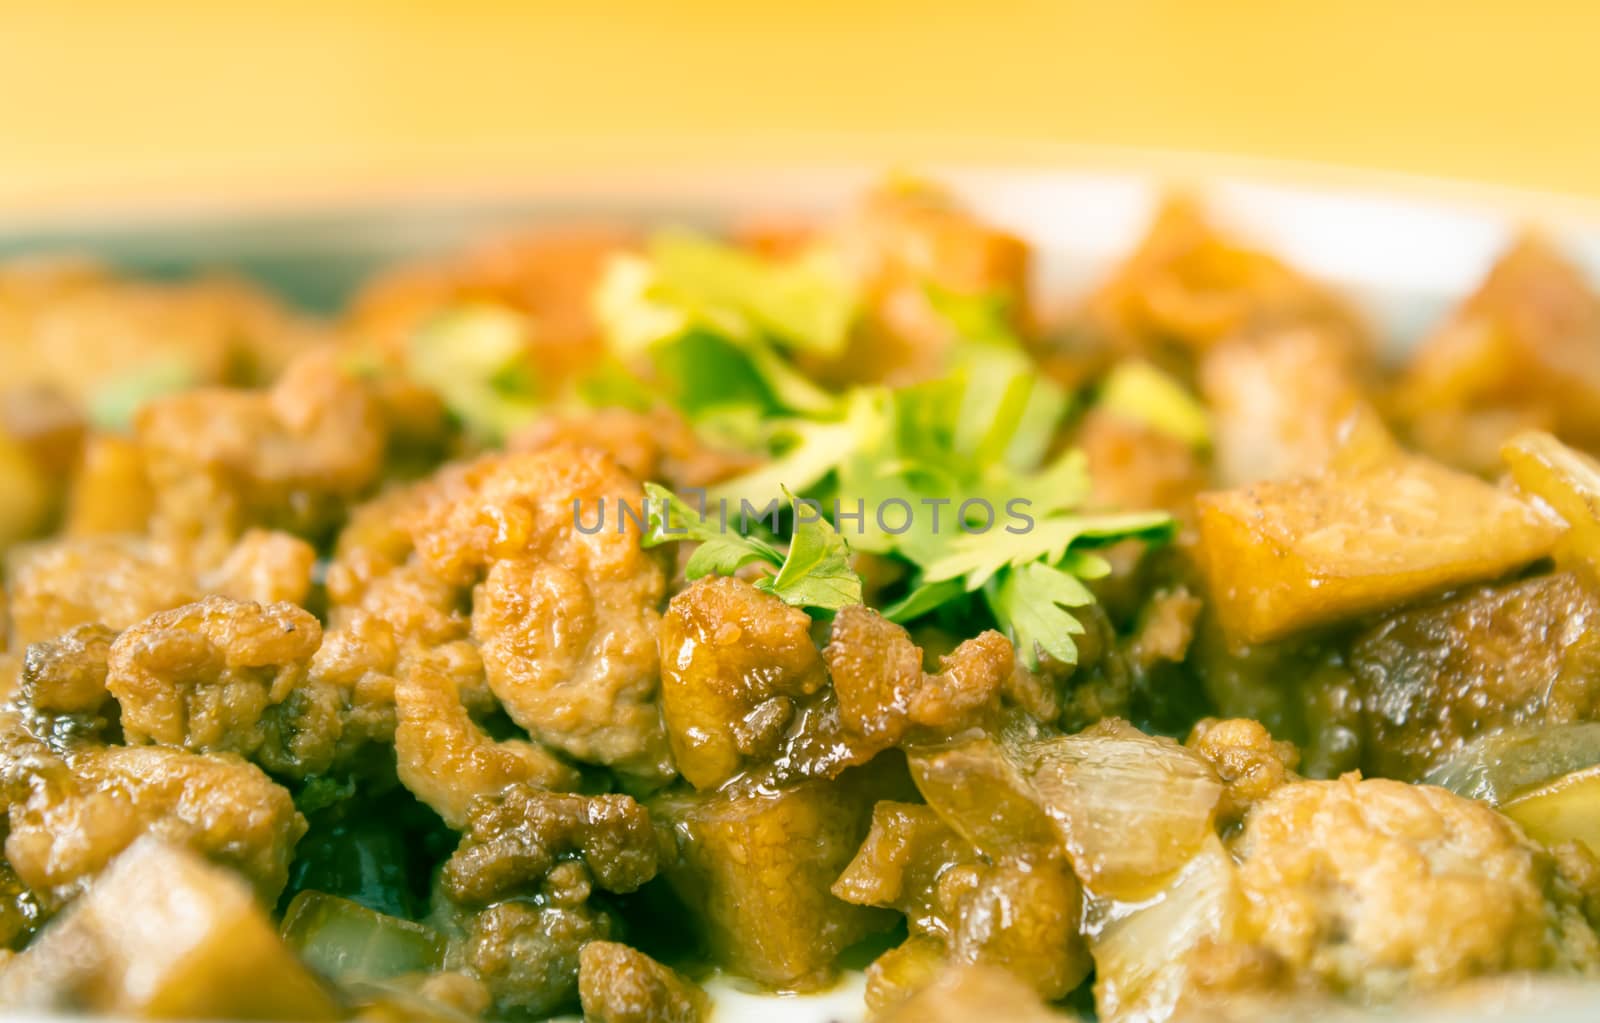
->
xmin=0 ymin=724 xmax=306 ymax=908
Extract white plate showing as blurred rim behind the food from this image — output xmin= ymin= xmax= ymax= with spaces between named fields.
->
xmin=9 ymin=154 xmax=1600 ymax=1023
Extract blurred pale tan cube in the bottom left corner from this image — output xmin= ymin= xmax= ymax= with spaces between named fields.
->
xmin=0 ymin=836 xmax=338 ymax=1020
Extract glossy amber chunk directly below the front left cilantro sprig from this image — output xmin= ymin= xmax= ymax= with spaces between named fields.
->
xmin=659 ymin=576 xmax=827 ymax=789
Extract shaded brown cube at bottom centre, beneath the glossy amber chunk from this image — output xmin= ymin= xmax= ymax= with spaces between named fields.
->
xmin=650 ymin=762 xmax=904 ymax=991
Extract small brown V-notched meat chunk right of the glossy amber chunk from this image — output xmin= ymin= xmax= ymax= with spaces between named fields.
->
xmin=822 ymin=604 xmax=1013 ymax=746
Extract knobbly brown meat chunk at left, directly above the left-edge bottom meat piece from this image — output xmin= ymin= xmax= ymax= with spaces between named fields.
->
xmin=106 ymin=597 xmax=344 ymax=776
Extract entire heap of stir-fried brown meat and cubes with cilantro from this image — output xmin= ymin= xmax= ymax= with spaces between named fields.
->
xmin=9 ymin=183 xmax=1600 ymax=1023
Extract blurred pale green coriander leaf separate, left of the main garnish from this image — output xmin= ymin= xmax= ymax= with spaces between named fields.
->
xmin=408 ymin=306 xmax=541 ymax=442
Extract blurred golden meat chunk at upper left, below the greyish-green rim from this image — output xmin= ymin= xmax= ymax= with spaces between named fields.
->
xmin=136 ymin=351 xmax=386 ymax=543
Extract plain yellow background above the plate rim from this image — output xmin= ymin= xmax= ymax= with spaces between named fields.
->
xmin=0 ymin=0 xmax=1600 ymax=210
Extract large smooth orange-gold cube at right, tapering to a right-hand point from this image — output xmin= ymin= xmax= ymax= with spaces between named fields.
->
xmin=1198 ymin=453 xmax=1565 ymax=644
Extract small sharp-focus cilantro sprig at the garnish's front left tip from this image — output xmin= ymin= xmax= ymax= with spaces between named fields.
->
xmin=642 ymin=483 xmax=861 ymax=612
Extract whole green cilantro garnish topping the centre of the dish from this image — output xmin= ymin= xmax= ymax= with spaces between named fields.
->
xmin=597 ymin=234 xmax=1177 ymax=666
